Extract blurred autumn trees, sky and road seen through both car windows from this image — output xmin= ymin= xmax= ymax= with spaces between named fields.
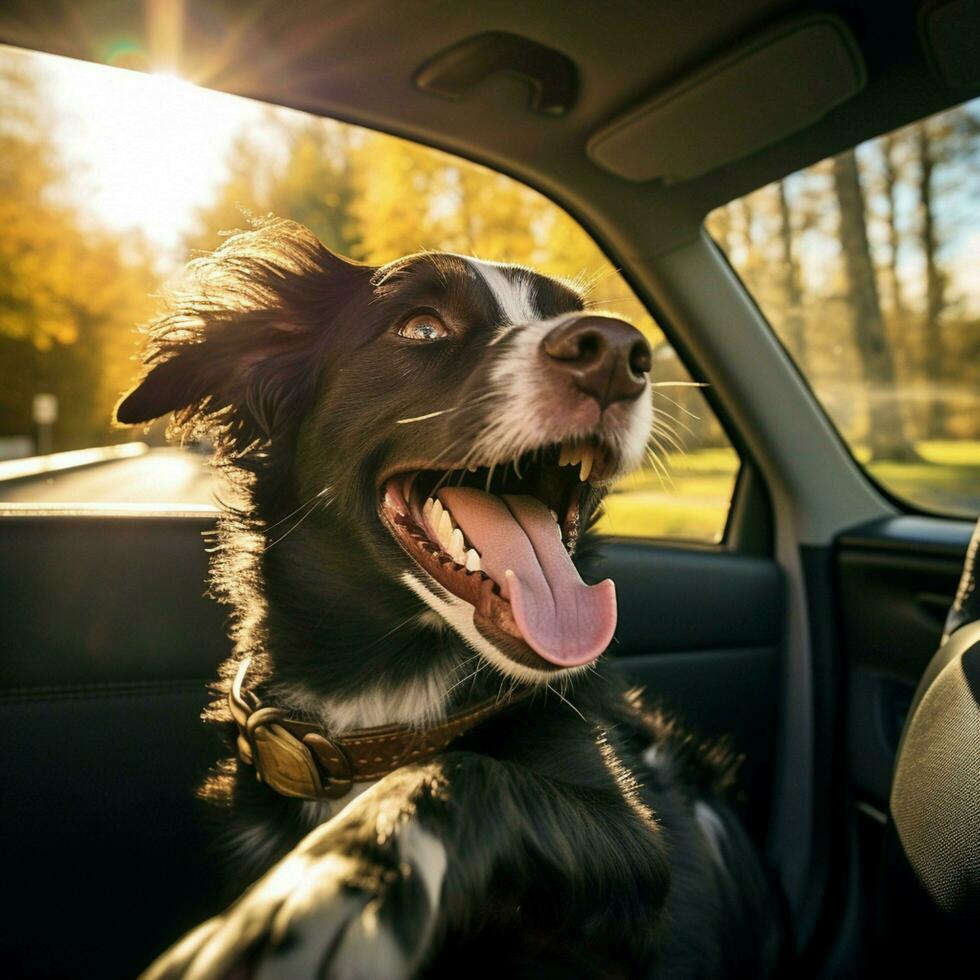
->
xmin=0 ymin=47 xmax=980 ymax=541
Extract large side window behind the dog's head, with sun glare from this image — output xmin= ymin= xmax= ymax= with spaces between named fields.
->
xmin=0 ymin=48 xmax=738 ymax=541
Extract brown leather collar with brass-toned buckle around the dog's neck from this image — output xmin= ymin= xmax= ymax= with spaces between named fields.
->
xmin=228 ymin=658 xmax=530 ymax=800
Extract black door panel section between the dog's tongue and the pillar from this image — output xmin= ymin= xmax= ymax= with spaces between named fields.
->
xmin=588 ymin=540 xmax=786 ymax=839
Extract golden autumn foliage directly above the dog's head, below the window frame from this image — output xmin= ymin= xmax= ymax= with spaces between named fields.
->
xmin=182 ymin=103 xmax=663 ymax=344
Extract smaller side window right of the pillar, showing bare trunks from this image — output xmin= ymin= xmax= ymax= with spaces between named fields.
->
xmin=707 ymin=99 xmax=980 ymax=518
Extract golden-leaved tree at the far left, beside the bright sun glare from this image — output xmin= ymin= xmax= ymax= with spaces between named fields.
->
xmin=0 ymin=53 xmax=157 ymax=449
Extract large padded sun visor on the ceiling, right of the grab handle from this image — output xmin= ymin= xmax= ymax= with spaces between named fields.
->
xmin=587 ymin=15 xmax=866 ymax=183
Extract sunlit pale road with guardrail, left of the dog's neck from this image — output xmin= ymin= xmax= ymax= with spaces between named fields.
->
xmin=0 ymin=449 xmax=215 ymax=507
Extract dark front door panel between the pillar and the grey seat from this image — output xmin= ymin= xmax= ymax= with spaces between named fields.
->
xmin=821 ymin=514 xmax=973 ymax=976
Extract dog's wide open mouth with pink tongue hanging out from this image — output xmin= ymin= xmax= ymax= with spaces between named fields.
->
xmin=381 ymin=442 xmax=616 ymax=670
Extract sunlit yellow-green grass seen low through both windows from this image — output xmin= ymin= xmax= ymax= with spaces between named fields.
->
xmin=598 ymin=440 xmax=980 ymax=543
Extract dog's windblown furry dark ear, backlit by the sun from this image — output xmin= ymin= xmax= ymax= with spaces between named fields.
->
xmin=115 ymin=220 xmax=374 ymax=449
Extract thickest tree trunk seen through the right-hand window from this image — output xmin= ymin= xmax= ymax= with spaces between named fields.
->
xmin=834 ymin=150 xmax=918 ymax=460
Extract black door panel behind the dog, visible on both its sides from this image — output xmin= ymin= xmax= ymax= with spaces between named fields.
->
xmin=0 ymin=508 xmax=784 ymax=975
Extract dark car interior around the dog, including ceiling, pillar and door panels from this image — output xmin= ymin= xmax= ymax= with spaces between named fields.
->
xmin=0 ymin=0 xmax=980 ymax=977
